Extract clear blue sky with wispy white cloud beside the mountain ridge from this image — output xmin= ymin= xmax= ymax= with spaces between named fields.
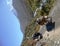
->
xmin=0 ymin=0 xmax=23 ymax=46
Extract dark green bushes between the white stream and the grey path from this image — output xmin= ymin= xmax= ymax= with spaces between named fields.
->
xmin=41 ymin=0 xmax=55 ymax=15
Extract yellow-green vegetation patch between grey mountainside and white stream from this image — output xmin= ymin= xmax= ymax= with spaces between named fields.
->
xmin=27 ymin=0 xmax=41 ymax=12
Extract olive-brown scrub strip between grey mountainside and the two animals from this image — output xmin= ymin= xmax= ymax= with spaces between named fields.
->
xmin=22 ymin=17 xmax=40 ymax=46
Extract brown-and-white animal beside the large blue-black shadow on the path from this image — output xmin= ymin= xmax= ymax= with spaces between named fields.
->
xmin=36 ymin=16 xmax=52 ymax=25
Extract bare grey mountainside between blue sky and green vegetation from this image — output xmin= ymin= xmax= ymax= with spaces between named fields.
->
xmin=12 ymin=0 xmax=33 ymax=33
